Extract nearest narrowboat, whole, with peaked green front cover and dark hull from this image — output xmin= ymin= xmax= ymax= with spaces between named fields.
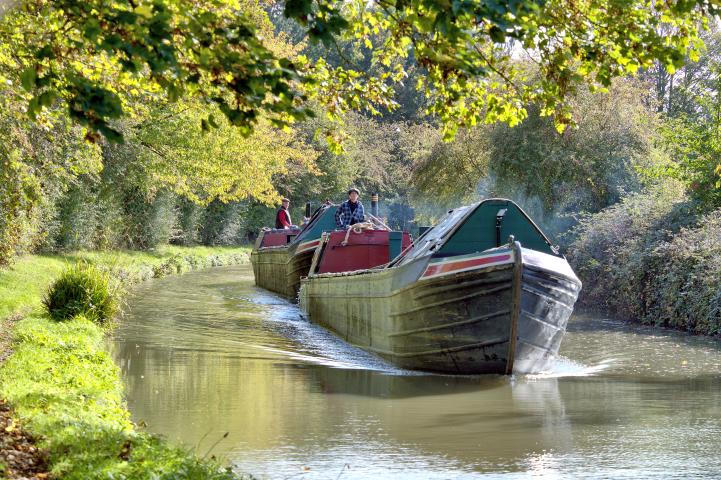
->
xmin=300 ymin=199 xmax=581 ymax=374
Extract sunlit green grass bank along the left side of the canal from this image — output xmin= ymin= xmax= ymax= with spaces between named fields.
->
xmin=0 ymin=247 xmax=249 ymax=479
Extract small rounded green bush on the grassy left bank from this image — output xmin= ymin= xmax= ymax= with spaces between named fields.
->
xmin=43 ymin=263 xmax=119 ymax=324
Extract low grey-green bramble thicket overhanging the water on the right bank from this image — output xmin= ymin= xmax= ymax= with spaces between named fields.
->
xmin=569 ymin=185 xmax=721 ymax=335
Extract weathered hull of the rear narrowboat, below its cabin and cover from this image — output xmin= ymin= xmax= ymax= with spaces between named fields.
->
xmin=250 ymin=247 xmax=313 ymax=301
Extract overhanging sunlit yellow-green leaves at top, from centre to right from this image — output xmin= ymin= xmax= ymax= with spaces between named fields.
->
xmin=286 ymin=0 xmax=712 ymax=138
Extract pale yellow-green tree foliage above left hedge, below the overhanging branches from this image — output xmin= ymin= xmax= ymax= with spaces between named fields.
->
xmin=130 ymin=104 xmax=317 ymax=204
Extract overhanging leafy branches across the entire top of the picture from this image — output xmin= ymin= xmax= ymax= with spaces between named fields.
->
xmin=0 ymin=0 xmax=718 ymax=140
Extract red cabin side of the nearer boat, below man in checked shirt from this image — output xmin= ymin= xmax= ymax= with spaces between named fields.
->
xmin=317 ymin=230 xmax=411 ymax=273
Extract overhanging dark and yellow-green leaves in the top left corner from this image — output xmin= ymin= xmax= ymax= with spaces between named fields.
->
xmin=0 ymin=0 xmax=314 ymax=140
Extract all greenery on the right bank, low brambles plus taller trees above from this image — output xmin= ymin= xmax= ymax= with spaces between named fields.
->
xmin=567 ymin=31 xmax=721 ymax=335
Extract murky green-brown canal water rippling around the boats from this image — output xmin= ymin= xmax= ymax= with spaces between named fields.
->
xmin=113 ymin=266 xmax=721 ymax=480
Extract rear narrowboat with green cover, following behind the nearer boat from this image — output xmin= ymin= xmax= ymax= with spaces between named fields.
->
xmin=250 ymin=204 xmax=336 ymax=300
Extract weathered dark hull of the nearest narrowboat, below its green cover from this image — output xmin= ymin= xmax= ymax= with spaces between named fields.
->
xmin=300 ymin=246 xmax=580 ymax=374
